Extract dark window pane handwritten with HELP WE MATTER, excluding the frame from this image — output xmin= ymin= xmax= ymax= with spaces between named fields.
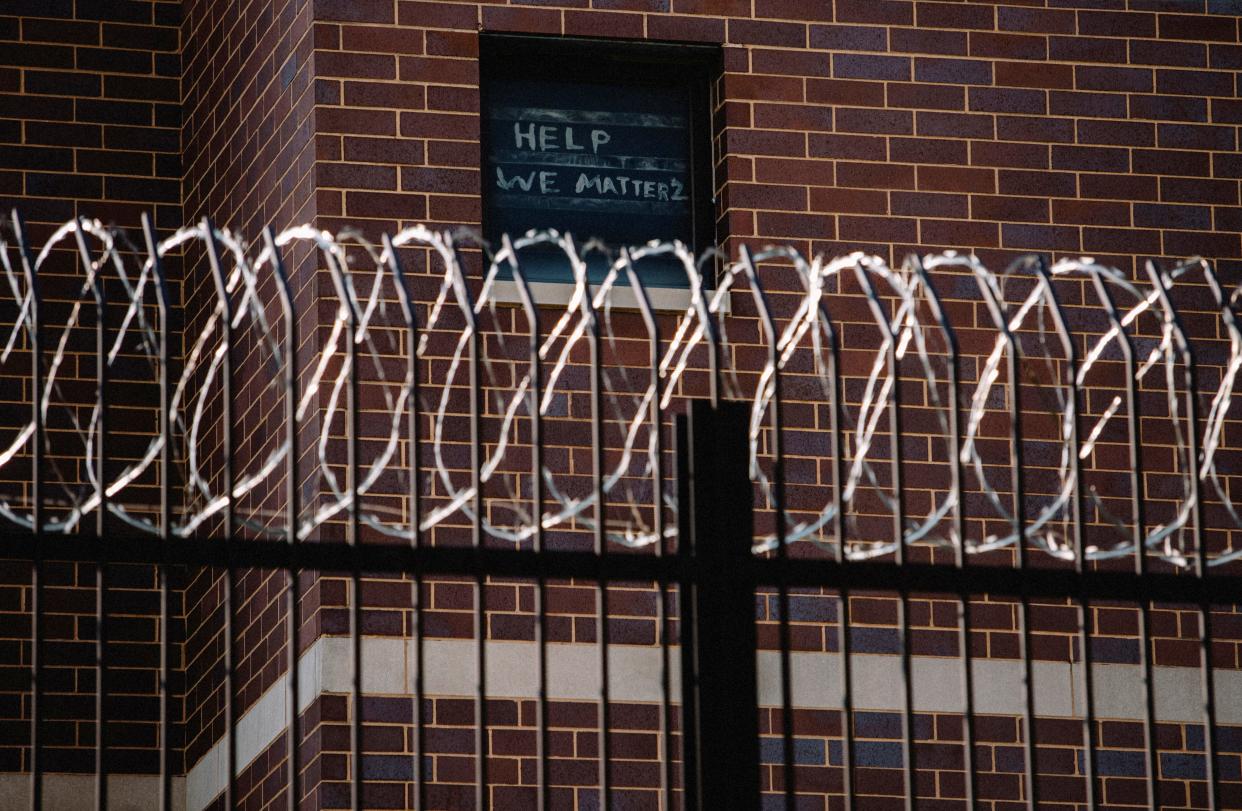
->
xmin=483 ymin=79 xmax=693 ymax=284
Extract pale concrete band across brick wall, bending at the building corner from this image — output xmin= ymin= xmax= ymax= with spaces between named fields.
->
xmin=162 ymin=636 xmax=1242 ymax=811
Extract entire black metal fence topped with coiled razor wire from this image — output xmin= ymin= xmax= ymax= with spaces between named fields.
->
xmin=0 ymin=212 xmax=1242 ymax=809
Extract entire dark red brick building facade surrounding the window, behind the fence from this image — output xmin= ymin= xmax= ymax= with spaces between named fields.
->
xmin=0 ymin=0 xmax=1242 ymax=811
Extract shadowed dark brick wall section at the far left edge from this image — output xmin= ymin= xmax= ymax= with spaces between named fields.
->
xmin=0 ymin=0 xmax=181 ymax=774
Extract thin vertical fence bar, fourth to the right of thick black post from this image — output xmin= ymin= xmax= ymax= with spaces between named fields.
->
xmin=910 ymin=256 xmax=979 ymax=809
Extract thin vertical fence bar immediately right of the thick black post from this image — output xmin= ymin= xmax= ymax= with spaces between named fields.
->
xmin=741 ymin=245 xmax=797 ymax=811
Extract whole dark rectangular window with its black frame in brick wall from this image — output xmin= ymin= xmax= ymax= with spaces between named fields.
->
xmin=479 ymin=35 xmax=719 ymax=294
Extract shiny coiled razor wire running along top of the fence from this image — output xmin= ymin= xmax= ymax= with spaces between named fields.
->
xmin=0 ymin=216 xmax=1242 ymax=566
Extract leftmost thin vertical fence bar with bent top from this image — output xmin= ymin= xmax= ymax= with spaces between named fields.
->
xmin=12 ymin=209 xmax=46 ymax=811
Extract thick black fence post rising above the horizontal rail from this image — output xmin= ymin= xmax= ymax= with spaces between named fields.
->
xmin=677 ymin=400 xmax=759 ymax=809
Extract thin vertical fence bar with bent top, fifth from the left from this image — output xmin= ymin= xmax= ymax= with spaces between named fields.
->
xmin=263 ymin=226 xmax=302 ymax=811
